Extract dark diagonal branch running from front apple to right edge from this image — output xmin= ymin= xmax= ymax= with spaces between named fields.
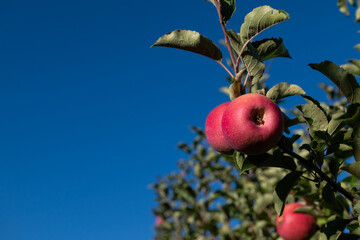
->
xmin=279 ymin=145 xmax=358 ymax=204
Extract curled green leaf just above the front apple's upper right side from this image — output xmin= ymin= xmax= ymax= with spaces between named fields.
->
xmin=266 ymin=82 xmax=306 ymax=101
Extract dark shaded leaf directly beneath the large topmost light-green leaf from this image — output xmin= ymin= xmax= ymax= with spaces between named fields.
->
xmin=252 ymin=38 xmax=291 ymax=61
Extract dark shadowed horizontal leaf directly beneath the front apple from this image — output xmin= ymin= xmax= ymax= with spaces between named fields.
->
xmin=241 ymin=153 xmax=296 ymax=172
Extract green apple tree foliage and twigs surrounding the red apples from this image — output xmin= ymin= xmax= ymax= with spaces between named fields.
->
xmin=152 ymin=0 xmax=360 ymax=240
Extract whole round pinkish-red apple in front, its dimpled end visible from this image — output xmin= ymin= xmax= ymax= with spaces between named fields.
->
xmin=221 ymin=93 xmax=284 ymax=155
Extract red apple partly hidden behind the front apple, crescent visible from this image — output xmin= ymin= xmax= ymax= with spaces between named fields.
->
xmin=205 ymin=102 xmax=234 ymax=154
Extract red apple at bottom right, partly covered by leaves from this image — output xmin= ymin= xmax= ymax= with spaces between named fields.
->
xmin=276 ymin=203 xmax=316 ymax=240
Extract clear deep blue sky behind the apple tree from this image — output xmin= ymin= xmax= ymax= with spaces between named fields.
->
xmin=0 ymin=0 xmax=360 ymax=240
